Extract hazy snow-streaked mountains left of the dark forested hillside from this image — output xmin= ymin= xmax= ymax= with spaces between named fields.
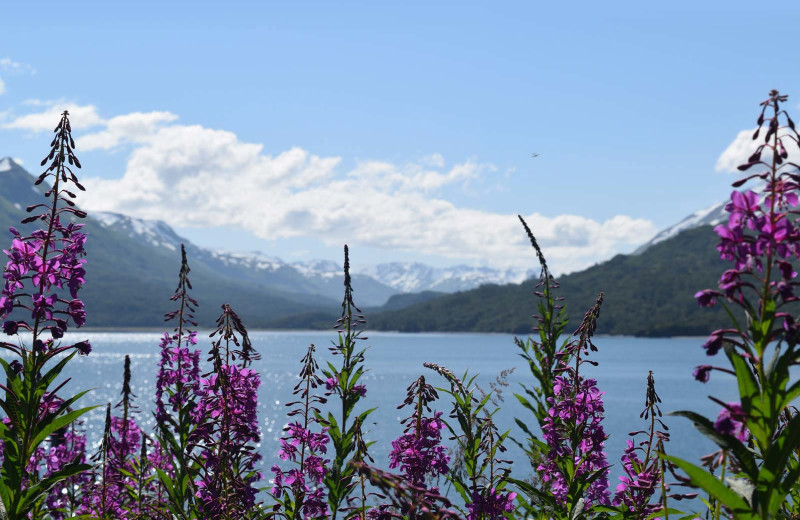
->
xmin=0 ymin=158 xmax=530 ymax=327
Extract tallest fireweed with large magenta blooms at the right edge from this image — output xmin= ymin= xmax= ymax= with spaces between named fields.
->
xmin=680 ymin=90 xmax=800 ymax=519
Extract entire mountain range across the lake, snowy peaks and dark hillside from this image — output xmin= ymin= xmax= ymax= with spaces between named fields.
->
xmin=0 ymin=154 xmax=744 ymax=336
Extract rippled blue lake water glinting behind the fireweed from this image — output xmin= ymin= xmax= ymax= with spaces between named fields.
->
xmin=25 ymin=331 xmax=737 ymax=498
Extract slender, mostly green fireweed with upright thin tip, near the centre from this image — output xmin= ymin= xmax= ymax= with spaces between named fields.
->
xmin=319 ymin=245 xmax=375 ymax=520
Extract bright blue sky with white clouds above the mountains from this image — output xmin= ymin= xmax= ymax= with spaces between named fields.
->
xmin=0 ymin=0 xmax=800 ymax=273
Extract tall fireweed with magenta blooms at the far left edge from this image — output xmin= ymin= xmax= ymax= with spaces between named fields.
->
xmin=0 ymin=111 xmax=92 ymax=520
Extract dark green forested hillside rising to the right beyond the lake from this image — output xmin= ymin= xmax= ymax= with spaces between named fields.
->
xmin=368 ymin=225 xmax=728 ymax=336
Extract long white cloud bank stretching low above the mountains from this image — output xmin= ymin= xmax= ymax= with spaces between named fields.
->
xmin=72 ymin=112 xmax=656 ymax=272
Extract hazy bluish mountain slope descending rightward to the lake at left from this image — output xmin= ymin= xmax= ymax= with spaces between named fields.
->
xmin=0 ymin=159 xmax=339 ymax=328
